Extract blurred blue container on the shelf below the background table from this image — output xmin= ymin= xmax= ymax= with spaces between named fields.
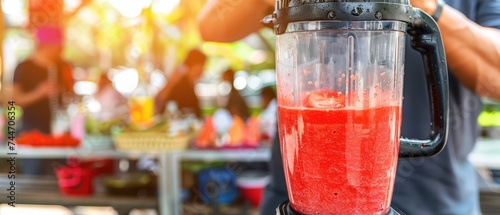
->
xmin=198 ymin=167 xmax=238 ymax=204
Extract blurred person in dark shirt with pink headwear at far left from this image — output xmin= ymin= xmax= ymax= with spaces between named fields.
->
xmin=12 ymin=26 xmax=73 ymax=174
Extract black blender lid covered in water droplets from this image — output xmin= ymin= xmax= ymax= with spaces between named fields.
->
xmin=270 ymin=0 xmax=413 ymax=35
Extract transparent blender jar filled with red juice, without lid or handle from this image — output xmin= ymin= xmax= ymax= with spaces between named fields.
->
xmin=276 ymin=21 xmax=407 ymax=214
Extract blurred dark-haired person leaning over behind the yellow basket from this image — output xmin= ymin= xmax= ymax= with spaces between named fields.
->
xmin=155 ymin=49 xmax=207 ymax=117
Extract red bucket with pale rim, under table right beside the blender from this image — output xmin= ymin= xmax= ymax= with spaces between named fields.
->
xmin=236 ymin=171 xmax=270 ymax=207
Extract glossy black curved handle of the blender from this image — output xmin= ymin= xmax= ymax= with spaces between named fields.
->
xmin=399 ymin=8 xmax=449 ymax=158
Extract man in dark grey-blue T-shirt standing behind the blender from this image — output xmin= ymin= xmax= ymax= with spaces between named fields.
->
xmin=199 ymin=0 xmax=500 ymax=215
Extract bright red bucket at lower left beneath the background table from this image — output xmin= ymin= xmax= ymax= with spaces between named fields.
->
xmin=55 ymin=166 xmax=94 ymax=195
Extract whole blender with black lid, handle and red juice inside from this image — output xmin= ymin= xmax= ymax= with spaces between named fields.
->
xmin=264 ymin=0 xmax=448 ymax=215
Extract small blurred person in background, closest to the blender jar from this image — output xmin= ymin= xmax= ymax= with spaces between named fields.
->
xmin=222 ymin=69 xmax=250 ymax=121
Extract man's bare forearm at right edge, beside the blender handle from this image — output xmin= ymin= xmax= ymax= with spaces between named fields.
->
xmin=438 ymin=6 xmax=500 ymax=100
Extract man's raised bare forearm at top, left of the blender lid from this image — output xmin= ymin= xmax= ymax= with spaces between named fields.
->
xmin=198 ymin=0 xmax=273 ymax=42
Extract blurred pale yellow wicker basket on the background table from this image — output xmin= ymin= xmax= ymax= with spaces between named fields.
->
xmin=114 ymin=132 xmax=191 ymax=151
